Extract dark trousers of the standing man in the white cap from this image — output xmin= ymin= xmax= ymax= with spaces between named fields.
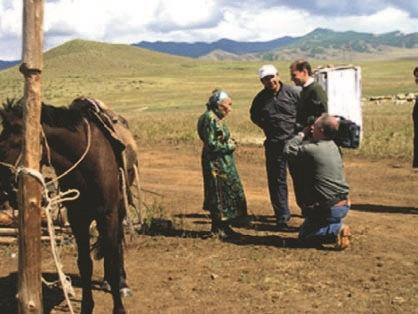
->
xmin=264 ymin=142 xmax=290 ymax=222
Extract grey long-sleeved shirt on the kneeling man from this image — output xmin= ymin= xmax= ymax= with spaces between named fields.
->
xmin=284 ymin=135 xmax=349 ymax=206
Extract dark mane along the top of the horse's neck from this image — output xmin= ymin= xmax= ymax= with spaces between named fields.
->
xmin=3 ymin=99 xmax=88 ymax=130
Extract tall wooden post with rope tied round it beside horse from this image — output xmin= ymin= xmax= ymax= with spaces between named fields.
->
xmin=18 ymin=0 xmax=44 ymax=314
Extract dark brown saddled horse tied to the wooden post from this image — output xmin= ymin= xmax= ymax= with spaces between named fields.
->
xmin=0 ymin=98 xmax=134 ymax=314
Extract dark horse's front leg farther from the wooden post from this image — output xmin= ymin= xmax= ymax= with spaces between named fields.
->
xmin=98 ymin=210 xmax=125 ymax=314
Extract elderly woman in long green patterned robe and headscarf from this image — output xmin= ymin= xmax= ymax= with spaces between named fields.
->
xmin=197 ymin=90 xmax=247 ymax=240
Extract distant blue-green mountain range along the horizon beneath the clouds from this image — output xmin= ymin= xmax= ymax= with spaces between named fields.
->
xmin=133 ymin=28 xmax=418 ymax=60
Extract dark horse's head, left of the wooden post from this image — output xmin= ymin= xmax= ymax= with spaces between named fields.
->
xmin=0 ymin=100 xmax=23 ymax=208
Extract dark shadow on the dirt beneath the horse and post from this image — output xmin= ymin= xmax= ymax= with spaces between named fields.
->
xmin=0 ymin=272 xmax=110 ymax=314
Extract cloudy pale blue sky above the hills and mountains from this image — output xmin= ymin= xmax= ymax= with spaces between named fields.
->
xmin=0 ymin=0 xmax=418 ymax=60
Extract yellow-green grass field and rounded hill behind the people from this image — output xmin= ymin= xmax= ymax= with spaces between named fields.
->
xmin=0 ymin=40 xmax=418 ymax=160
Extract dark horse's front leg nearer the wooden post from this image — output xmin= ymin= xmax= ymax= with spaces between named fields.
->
xmin=71 ymin=221 xmax=94 ymax=314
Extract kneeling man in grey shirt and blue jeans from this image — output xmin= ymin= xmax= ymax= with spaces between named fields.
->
xmin=284 ymin=114 xmax=351 ymax=250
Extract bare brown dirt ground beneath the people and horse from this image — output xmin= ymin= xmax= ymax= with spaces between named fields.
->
xmin=0 ymin=146 xmax=418 ymax=313
